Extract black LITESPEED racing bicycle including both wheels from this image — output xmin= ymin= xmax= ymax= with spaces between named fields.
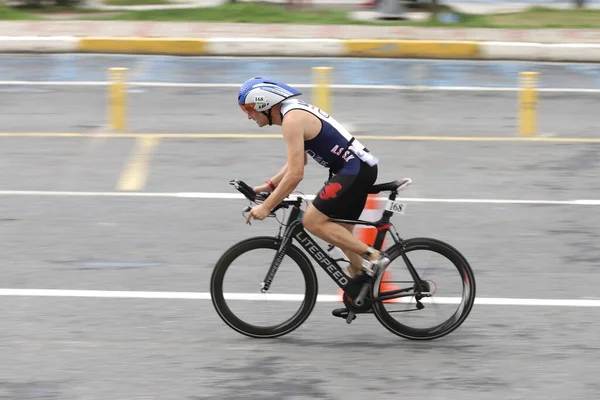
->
xmin=210 ymin=178 xmax=475 ymax=340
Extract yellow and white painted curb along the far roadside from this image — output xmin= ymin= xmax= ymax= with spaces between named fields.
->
xmin=0 ymin=36 xmax=600 ymax=62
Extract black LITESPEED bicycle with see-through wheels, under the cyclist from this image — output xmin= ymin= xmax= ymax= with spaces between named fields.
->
xmin=210 ymin=178 xmax=476 ymax=340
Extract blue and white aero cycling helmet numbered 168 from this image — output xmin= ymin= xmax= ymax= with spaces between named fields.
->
xmin=238 ymin=76 xmax=302 ymax=125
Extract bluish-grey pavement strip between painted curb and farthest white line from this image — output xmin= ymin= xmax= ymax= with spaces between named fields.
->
xmin=0 ymin=54 xmax=600 ymax=88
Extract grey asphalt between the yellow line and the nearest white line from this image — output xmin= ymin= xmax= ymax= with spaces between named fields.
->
xmin=0 ymin=138 xmax=600 ymax=298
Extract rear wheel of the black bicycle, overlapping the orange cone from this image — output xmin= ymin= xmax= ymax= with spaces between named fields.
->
xmin=372 ymin=238 xmax=476 ymax=340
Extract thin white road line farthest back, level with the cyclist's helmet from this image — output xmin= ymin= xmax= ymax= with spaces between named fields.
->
xmin=0 ymin=81 xmax=600 ymax=93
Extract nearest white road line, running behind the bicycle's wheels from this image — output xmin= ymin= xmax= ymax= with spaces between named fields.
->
xmin=0 ymin=289 xmax=600 ymax=307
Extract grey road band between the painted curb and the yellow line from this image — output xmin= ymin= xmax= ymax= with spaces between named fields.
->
xmin=0 ymin=55 xmax=600 ymax=137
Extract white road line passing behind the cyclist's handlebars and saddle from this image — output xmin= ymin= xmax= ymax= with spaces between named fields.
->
xmin=0 ymin=190 xmax=600 ymax=206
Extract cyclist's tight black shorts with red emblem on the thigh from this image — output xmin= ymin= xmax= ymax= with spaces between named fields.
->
xmin=312 ymin=162 xmax=377 ymax=220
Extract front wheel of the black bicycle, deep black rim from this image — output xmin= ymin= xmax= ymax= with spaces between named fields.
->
xmin=210 ymin=237 xmax=318 ymax=338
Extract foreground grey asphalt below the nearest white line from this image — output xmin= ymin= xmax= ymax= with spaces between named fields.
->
xmin=0 ymin=299 xmax=599 ymax=400
